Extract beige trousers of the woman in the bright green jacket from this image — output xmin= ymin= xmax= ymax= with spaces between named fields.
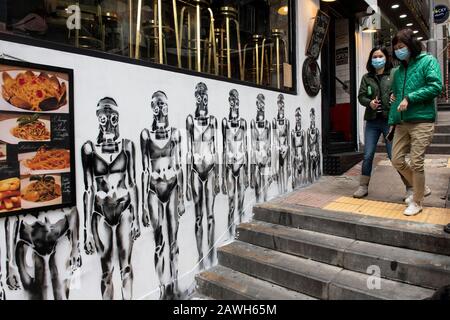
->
xmin=392 ymin=123 xmax=434 ymax=203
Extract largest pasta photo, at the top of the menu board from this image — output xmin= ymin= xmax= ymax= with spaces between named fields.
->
xmin=0 ymin=70 xmax=69 ymax=113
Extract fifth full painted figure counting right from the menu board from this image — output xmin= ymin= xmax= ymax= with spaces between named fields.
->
xmin=250 ymin=94 xmax=272 ymax=202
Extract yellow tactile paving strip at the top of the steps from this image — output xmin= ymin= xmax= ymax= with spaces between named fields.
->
xmin=322 ymin=196 xmax=450 ymax=225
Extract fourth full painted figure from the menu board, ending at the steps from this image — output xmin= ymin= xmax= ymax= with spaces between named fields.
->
xmin=222 ymin=89 xmax=249 ymax=235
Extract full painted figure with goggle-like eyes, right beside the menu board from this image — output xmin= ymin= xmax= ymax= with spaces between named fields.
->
xmin=81 ymin=97 xmax=140 ymax=299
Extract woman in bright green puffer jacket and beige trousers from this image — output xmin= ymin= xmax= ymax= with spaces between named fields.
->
xmin=389 ymin=29 xmax=442 ymax=216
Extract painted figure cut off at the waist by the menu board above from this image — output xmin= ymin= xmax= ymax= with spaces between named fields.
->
xmin=5 ymin=208 xmax=81 ymax=300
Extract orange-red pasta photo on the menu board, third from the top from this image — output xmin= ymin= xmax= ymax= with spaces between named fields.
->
xmin=19 ymin=146 xmax=70 ymax=175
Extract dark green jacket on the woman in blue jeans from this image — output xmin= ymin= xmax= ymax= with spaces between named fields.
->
xmin=358 ymin=72 xmax=393 ymax=121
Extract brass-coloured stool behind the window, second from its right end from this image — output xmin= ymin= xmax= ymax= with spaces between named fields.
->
xmin=244 ymin=34 xmax=267 ymax=84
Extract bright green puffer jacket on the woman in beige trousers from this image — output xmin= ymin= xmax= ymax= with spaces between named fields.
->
xmin=389 ymin=53 xmax=442 ymax=125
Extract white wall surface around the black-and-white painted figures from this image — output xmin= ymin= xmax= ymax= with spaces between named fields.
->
xmin=0 ymin=0 xmax=322 ymax=299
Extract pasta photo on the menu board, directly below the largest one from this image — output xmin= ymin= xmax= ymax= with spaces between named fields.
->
xmin=0 ymin=114 xmax=51 ymax=144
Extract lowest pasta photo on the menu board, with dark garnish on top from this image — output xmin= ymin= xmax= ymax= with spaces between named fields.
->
xmin=20 ymin=175 xmax=62 ymax=209
